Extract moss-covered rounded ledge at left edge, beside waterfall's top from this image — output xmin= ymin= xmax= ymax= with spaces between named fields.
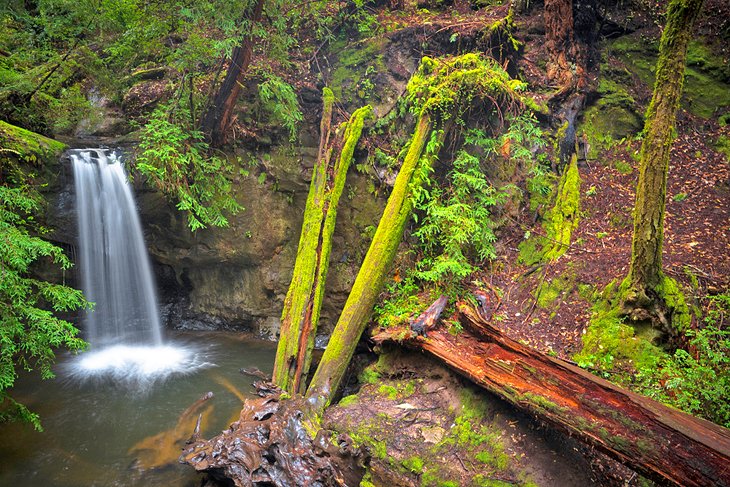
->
xmin=0 ymin=120 xmax=66 ymax=163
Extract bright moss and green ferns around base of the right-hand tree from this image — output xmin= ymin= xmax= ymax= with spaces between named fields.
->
xmin=574 ymin=281 xmax=730 ymax=427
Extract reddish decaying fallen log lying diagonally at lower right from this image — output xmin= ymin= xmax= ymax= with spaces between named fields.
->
xmin=373 ymin=305 xmax=730 ymax=486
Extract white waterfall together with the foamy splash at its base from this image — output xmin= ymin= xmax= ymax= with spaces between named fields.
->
xmin=69 ymin=149 xmax=204 ymax=384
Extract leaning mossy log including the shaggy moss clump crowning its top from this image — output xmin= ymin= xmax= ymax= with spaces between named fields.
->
xmin=308 ymin=54 xmax=526 ymax=402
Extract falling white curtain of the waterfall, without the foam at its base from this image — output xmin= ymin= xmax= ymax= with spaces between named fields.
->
xmin=70 ymin=149 xmax=162 ymax=347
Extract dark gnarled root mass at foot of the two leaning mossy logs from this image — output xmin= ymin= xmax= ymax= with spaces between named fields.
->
xmin=180 ymin=381 xmax=369 ymax=487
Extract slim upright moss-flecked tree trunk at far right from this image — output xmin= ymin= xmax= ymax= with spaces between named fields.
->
xmin=626 ymin=0 xmax=702 ymax=308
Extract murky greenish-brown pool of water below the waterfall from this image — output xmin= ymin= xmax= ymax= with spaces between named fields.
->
xmin=0 ymin=332 xmax=276 ymax=487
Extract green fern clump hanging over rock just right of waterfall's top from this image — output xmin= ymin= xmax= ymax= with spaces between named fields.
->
xmin=137 ymin=108 xmax=243 ymax=230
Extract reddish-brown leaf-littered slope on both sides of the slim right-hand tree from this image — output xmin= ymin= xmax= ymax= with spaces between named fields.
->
xmin=482 ymin=112 xmax=730 ymax=359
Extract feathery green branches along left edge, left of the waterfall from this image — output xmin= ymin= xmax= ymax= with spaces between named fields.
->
xmin=0 ymin=165 xmax=87 ymax=430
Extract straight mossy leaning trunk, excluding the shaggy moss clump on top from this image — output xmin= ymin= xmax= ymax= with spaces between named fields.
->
xmin=308 ymin=113 xmax=444 ymax=400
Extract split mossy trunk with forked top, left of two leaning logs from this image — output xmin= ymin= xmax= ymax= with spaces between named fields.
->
xmin=273 ymin=88 xmax=372 ymax=393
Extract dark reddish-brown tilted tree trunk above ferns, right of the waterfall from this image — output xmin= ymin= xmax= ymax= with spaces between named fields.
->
xmin=200 ymin=0 xmax=264 ymax=147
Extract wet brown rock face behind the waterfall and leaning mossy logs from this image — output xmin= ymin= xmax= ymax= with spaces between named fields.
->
xmin=45 ymin=141 xmax=383 ymax=338
